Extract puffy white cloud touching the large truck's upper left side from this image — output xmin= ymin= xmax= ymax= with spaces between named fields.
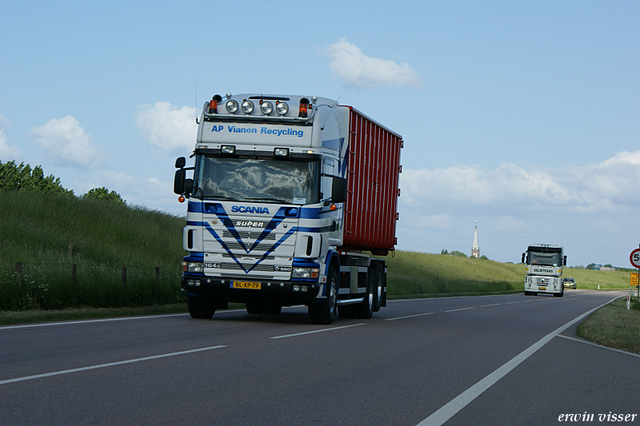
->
xmin=136 ymin=102 xmax=198 ymax=152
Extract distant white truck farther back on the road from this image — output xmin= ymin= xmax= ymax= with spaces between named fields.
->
xmin=522 ymin=244 xmax=567 ymax=297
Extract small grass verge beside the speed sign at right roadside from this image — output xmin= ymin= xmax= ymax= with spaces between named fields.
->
xmin=576 ymin=297 xmax=640 ymax=353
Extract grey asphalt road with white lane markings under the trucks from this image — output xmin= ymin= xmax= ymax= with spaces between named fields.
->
xmin=0 ymin=290 xmax=640 ymax=426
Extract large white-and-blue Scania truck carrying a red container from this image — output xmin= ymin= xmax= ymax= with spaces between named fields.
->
xmin=174 ymin=94 xmax=403 ymax=324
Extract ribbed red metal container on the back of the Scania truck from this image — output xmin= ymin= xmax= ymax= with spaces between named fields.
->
xmin=340 ymin=106 xmax=403 ymax=256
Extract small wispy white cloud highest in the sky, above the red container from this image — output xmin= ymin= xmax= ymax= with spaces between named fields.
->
xmin=324 ymin=37 xmax=422 ymax=89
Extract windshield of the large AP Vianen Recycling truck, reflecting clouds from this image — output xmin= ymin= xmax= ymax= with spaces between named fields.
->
xmin=193 ymin=155 xmax=320 ymax=204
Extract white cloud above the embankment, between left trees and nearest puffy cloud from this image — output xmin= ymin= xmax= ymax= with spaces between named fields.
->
xmin=29 ymin=115 xmax=103 ymax=167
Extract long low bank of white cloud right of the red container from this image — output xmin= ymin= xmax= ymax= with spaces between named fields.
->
xmin=401 ymin=150 xmax=640 ymax=214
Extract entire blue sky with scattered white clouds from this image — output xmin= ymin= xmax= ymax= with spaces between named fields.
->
xmin=0 ymin=0 xmax=640 ymax=267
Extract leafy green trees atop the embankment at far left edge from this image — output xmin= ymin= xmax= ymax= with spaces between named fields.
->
xmin=0 ymin=161 xmax=73 ymax=195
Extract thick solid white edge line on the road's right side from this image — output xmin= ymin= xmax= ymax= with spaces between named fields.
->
xmin=417 ymin=296 xmax=618 ymax=426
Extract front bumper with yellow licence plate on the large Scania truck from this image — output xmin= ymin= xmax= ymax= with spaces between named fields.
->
xmin=181 ymin=274 xmax=320 ymax=306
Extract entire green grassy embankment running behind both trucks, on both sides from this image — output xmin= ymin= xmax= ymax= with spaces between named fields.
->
xmin=0 ymin=191 xmax=629 ymax=311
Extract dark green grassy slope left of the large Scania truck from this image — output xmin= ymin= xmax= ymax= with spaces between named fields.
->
xmin=0 ymin=191 xmax=184 ymax=310
